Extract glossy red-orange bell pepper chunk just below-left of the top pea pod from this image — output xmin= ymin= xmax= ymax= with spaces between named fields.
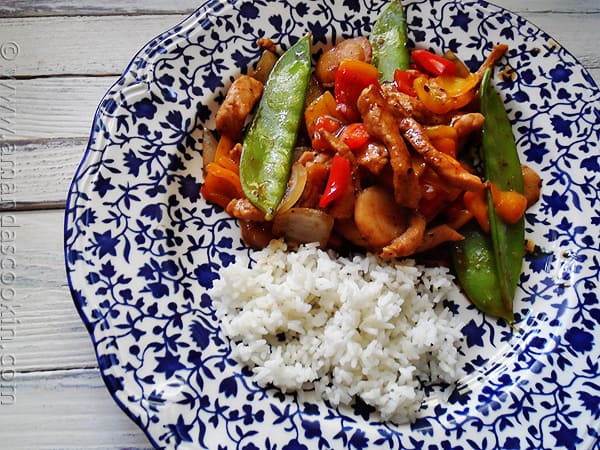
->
xmin=333 ymin=59 xmax=379 ymax=122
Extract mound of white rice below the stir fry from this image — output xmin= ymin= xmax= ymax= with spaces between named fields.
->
xmin=209 ymin=240 xmax=463 ymax=423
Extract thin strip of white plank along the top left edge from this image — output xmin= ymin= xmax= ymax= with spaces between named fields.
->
xmin=0 ymin=0 xmax=200 ymax=17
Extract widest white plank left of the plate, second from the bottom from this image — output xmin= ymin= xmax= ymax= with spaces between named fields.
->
xmin=2 ymin=210 xmax=97 ymax=372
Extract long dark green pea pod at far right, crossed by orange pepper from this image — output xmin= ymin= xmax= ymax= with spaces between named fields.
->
xmin=480 ymin=69 xmax=525 ymax=316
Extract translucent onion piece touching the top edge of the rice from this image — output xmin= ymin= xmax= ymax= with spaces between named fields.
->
xmin=273 ymin=208 xmax=334 ymax=247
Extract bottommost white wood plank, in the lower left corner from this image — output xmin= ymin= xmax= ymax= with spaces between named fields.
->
xmin=0 ymin=369 xmax=152 ymax=450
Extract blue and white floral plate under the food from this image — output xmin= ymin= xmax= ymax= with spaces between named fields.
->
xmin=65 ymin=0 xmax=600 ymax=450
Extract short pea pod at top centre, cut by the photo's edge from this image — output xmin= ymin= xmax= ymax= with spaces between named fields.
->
xmin=369 ymin=0 xmax=410 ymax=82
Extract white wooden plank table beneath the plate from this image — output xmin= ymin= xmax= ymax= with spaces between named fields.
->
xmin=0 ymin=0 xmax=600 ymax=449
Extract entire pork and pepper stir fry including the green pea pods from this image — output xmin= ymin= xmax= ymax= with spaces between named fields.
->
xmin=202 ymin=0 xmax=539 ymax=321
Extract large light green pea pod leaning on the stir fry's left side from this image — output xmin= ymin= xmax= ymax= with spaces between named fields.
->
xmin=240 ymin=35 xmax=311 ymax=220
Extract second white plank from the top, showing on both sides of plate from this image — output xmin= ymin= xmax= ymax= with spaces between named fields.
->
xmin=0 ymin=12 xmax=600 ymax=77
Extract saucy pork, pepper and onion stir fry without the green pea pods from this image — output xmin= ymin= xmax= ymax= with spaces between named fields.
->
xmin=202 ymin=37 xmax=539 ymax=258
